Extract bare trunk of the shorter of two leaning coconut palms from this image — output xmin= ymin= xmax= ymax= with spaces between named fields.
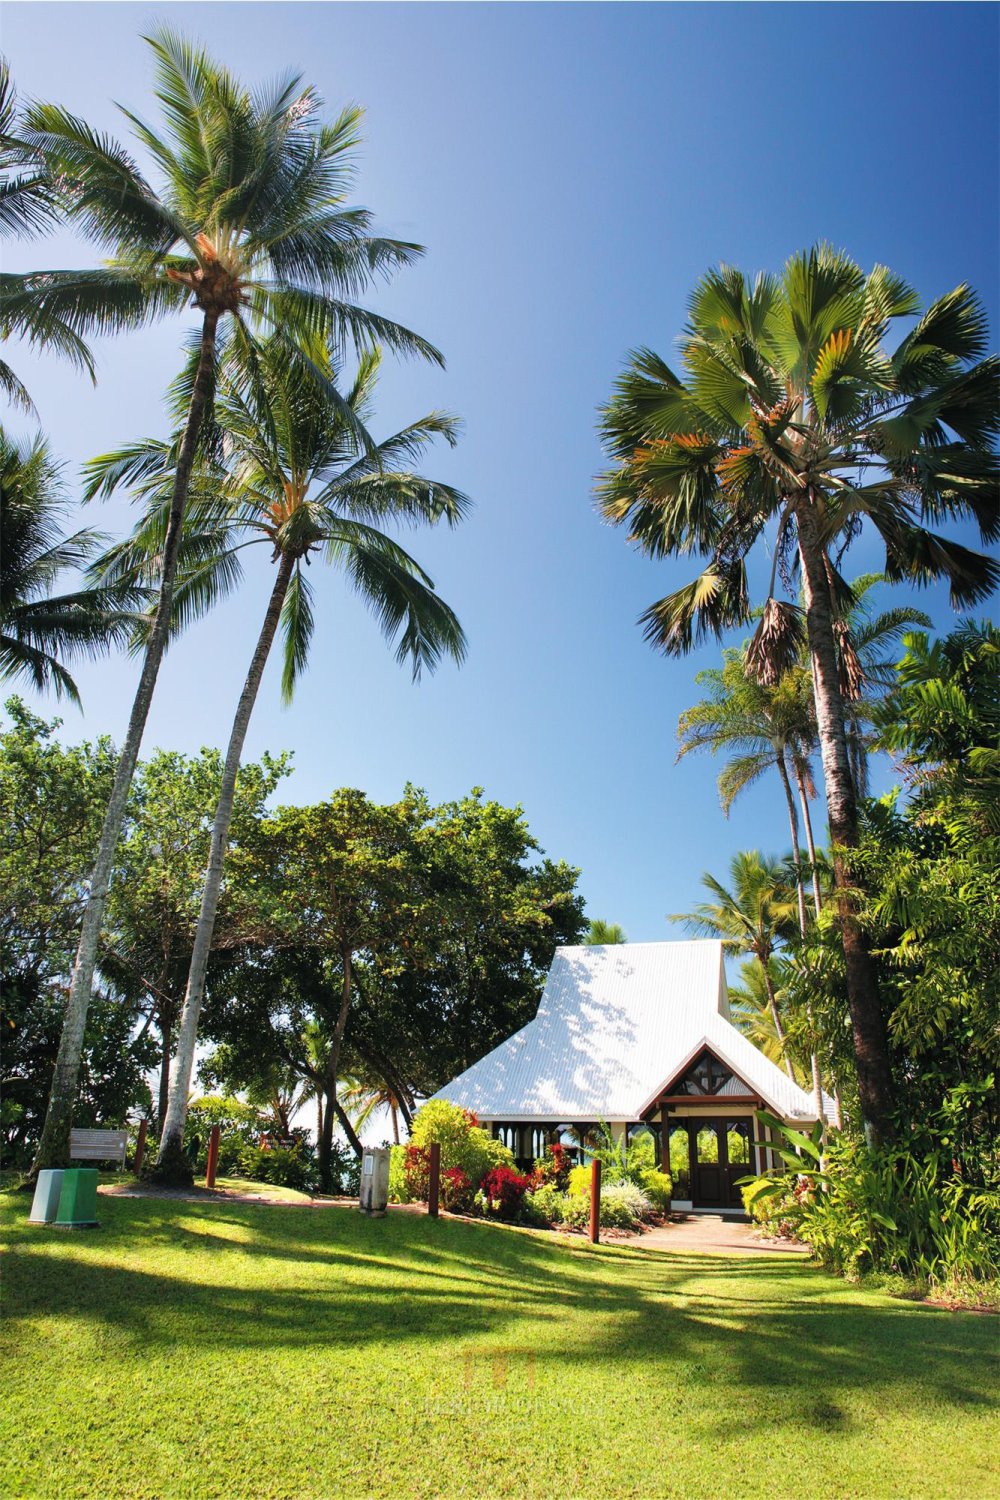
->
xmin=154 ymin=552 xmax=295 ymax=1184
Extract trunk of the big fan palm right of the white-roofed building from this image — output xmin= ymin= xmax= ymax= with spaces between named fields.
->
xmin=796 ymin=492 xmax=892 ymax=1146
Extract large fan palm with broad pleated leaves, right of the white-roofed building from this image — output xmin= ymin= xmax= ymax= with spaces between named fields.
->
xmin=601 ymin=246 xmax=1000 ymax=1142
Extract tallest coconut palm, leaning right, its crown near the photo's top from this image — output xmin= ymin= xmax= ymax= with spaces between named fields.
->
xmin=24 ymin=30 xmax=441 ymax=1172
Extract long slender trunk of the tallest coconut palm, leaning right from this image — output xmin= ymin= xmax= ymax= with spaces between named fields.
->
xmin=28 ymin=312 xmax=219 ymax=1182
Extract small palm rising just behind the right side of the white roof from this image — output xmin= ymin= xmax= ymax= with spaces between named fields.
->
xmin=670 ymin=849 xmax=795 ymax=1079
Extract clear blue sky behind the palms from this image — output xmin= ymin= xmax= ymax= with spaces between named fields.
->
xmin=3 ymin=5 xmax=999 ymax=939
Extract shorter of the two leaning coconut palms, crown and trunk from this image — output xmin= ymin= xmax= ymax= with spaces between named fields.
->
xmin=93 ymin=338 xmax=468 ymax=1179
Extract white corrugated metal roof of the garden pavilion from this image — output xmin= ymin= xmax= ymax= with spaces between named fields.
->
xmin=435 ymin=941 xmax=832 ymax=1122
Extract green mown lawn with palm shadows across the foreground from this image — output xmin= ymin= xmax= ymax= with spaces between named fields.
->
xmin=0 ymin=1194 xmax=1000 ymax=1500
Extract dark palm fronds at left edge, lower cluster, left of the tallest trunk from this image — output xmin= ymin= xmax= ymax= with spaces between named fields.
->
xmin=0 ymin=428 xmax=141 ymax=704
